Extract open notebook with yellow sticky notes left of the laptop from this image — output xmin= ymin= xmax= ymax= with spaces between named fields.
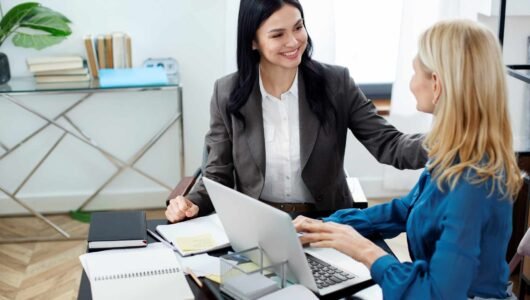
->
xmin=156 ymin=214 xmax=230 ymax=256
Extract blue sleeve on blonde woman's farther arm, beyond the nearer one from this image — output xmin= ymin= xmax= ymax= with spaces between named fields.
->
xmin=323 ymin=171 xmax=427 ymax=238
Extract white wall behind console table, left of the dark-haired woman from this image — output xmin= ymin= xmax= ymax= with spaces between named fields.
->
xmin=0 ymin=0 xmax=227 ymax=214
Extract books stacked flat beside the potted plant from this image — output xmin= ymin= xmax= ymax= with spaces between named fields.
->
xmin=26 ymin=56 xmax=90 ymax=83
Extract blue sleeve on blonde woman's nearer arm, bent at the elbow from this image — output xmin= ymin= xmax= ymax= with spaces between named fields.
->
xmin=370 ymin=181 xmax=486 ymax=299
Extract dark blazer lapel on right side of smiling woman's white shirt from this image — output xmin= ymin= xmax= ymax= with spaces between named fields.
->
xmin=298 ymin=73 xmax=320 ymax=170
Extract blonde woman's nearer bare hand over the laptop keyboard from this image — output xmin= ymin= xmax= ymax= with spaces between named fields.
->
xmin=295 ymin=220 xmax=387 ymax=269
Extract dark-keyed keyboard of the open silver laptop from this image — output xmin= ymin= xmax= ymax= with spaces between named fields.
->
xmin=306 ymin=253 xmax=355 ymax=289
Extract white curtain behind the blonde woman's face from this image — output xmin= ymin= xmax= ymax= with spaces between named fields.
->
xmin=383 ymin=0 xmax=480 ymax=191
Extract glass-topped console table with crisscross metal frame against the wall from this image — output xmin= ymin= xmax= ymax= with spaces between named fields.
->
xmin=0 ymin=77 xmax=184 ymax=242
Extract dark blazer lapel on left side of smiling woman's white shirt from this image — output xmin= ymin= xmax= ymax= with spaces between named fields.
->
xmin=241 ymin=80 xmax=265 ymax=178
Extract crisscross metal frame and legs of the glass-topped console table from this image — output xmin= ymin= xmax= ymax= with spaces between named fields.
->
xmin=0 ymin=79 xmax=184 ymax=243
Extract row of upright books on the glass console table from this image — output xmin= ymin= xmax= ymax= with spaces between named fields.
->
xmin=84 ymin=32 xmax=132 ymax=78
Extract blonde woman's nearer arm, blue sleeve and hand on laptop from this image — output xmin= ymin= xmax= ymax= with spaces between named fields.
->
xmin=299 ymin=179 xmax=486 ymax=299
